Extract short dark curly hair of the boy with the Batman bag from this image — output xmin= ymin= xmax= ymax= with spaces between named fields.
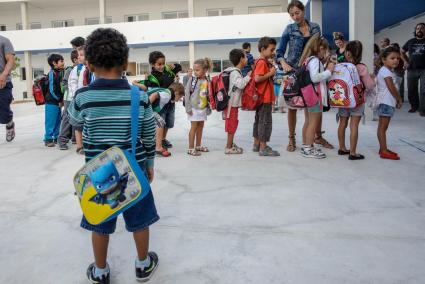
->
xmin=85 ymin=28 xmax=128 ymax=69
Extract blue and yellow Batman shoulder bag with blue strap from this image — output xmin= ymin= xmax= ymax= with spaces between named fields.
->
xmin=74 ymin=86 xmax=151 ymax=225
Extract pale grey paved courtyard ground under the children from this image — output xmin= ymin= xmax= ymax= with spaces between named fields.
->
xmin=0 ymin=103 xmax=425 ymax=284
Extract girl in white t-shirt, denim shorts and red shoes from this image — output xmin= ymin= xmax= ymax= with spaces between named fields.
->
xmin=377 ymin=46 xmax=402 ymax=160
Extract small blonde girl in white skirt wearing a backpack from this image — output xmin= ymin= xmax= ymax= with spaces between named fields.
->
xmin=184 ymin=58 xmax=212 ymax=156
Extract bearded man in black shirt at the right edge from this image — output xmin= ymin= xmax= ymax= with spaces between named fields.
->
xmin=401 ymin=23 xmax=425 ymax=117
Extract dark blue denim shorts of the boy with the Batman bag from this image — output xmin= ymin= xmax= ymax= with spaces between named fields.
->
xmin=81 ymin=191 xmax=159 ymax=235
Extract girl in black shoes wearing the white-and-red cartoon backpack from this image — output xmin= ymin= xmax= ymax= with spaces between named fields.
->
xmin=338 ymin=40 xmax=375 ymax=160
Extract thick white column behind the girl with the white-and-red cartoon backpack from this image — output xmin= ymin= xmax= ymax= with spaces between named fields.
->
xmin=349 ymin=0 xmax=375 ymax=120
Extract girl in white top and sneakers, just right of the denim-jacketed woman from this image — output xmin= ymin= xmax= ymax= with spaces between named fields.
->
xmin=300 ymin=34 xmax=335 ymax=159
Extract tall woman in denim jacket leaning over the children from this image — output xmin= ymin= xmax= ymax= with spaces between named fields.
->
xmin=276 ymin=0 xmax=333 ymax=152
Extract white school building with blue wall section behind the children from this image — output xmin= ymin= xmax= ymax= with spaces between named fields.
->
xmin=0 ymin=0 xmax=425 ymax=100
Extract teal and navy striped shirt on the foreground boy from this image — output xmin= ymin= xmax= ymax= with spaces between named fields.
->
xmin=68 ymin=78 xmax=155 ymax=168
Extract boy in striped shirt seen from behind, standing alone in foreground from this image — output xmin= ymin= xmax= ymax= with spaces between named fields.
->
xmin=68 ymin=29 xmax=159 ymax=284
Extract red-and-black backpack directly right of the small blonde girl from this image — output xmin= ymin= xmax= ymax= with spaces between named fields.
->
xmin=208 ymin=69 xmax=241 ymax=111
